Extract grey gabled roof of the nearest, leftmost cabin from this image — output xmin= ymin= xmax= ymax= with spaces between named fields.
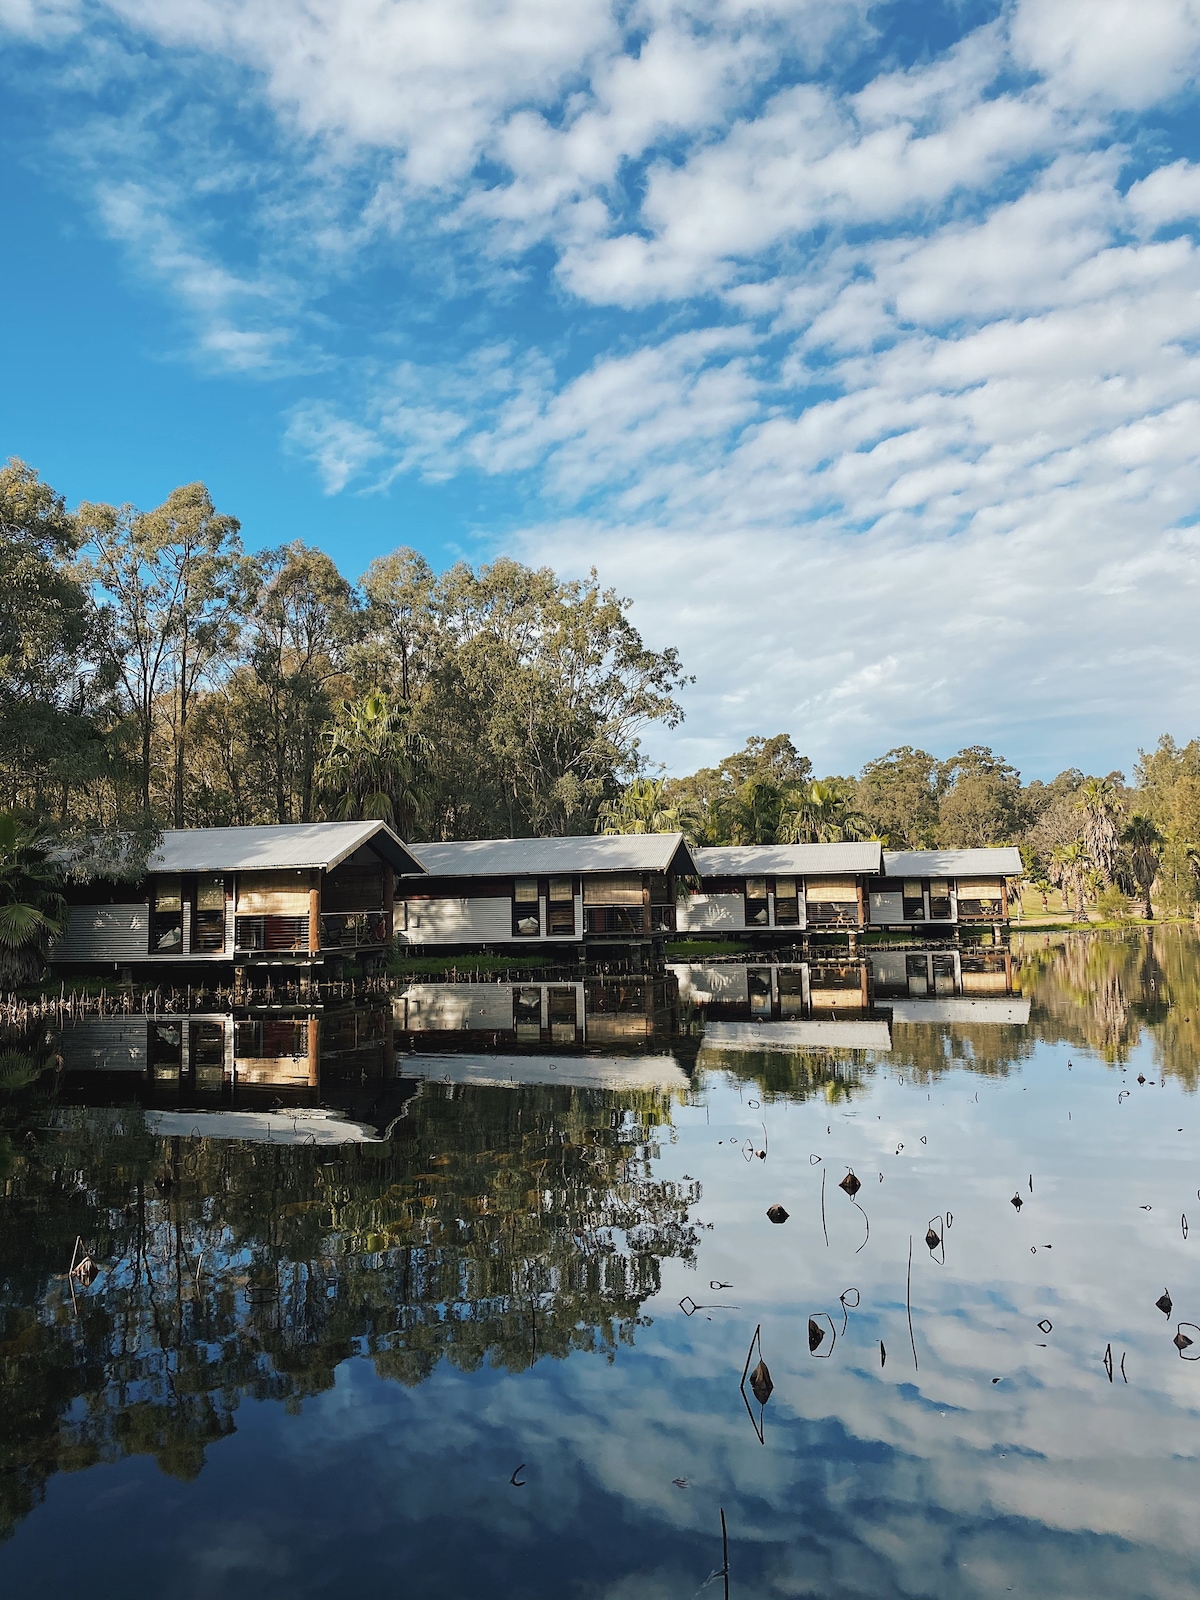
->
xmin=147 ymin=822 xmax=424 ymax=872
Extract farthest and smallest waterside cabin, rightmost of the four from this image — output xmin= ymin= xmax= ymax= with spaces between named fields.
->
xmin=870 ymin=845 xmax=1022 ymax=931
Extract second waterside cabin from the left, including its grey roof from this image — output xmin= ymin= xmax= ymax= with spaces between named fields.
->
xmin=395 ymin=834 xmax=696 ymax=949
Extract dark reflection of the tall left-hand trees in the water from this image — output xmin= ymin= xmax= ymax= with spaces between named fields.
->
xmin=0 ymin=1088 xmax=699 ymax=1531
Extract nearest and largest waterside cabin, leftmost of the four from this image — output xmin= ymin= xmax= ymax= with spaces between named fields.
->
xmin=53 ymin=822 xmax=421 ymax=970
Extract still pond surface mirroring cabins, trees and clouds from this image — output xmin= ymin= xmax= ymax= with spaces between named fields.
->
xmin=0 ymin=931 xmax=1200 ymax=1600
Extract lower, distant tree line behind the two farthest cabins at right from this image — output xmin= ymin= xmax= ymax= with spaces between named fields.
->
xmin=598 ymin=733 xmax=1200 ymax=920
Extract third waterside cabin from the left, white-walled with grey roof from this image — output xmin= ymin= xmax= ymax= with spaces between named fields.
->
xmin=678 ymin=842 xmax=883 ymax=934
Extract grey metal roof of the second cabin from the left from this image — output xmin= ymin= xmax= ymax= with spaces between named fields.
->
xmin=413 ymin=834 xmax=694 ymax=878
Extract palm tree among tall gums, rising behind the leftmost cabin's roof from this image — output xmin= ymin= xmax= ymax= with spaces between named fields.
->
xmin=317 ymin=690 xmax=421 ymax=837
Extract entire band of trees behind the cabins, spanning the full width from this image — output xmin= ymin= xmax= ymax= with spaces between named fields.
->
xmin=0 ymin=461 xmax=1200 ymax=946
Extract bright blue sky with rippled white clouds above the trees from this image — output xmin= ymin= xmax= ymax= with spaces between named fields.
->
xmin=0 ymin=0 xmax=1200 ymax=776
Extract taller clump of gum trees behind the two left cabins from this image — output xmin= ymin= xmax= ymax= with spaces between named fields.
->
xmin=0 ymin=461 xmax=685 ymax=838
